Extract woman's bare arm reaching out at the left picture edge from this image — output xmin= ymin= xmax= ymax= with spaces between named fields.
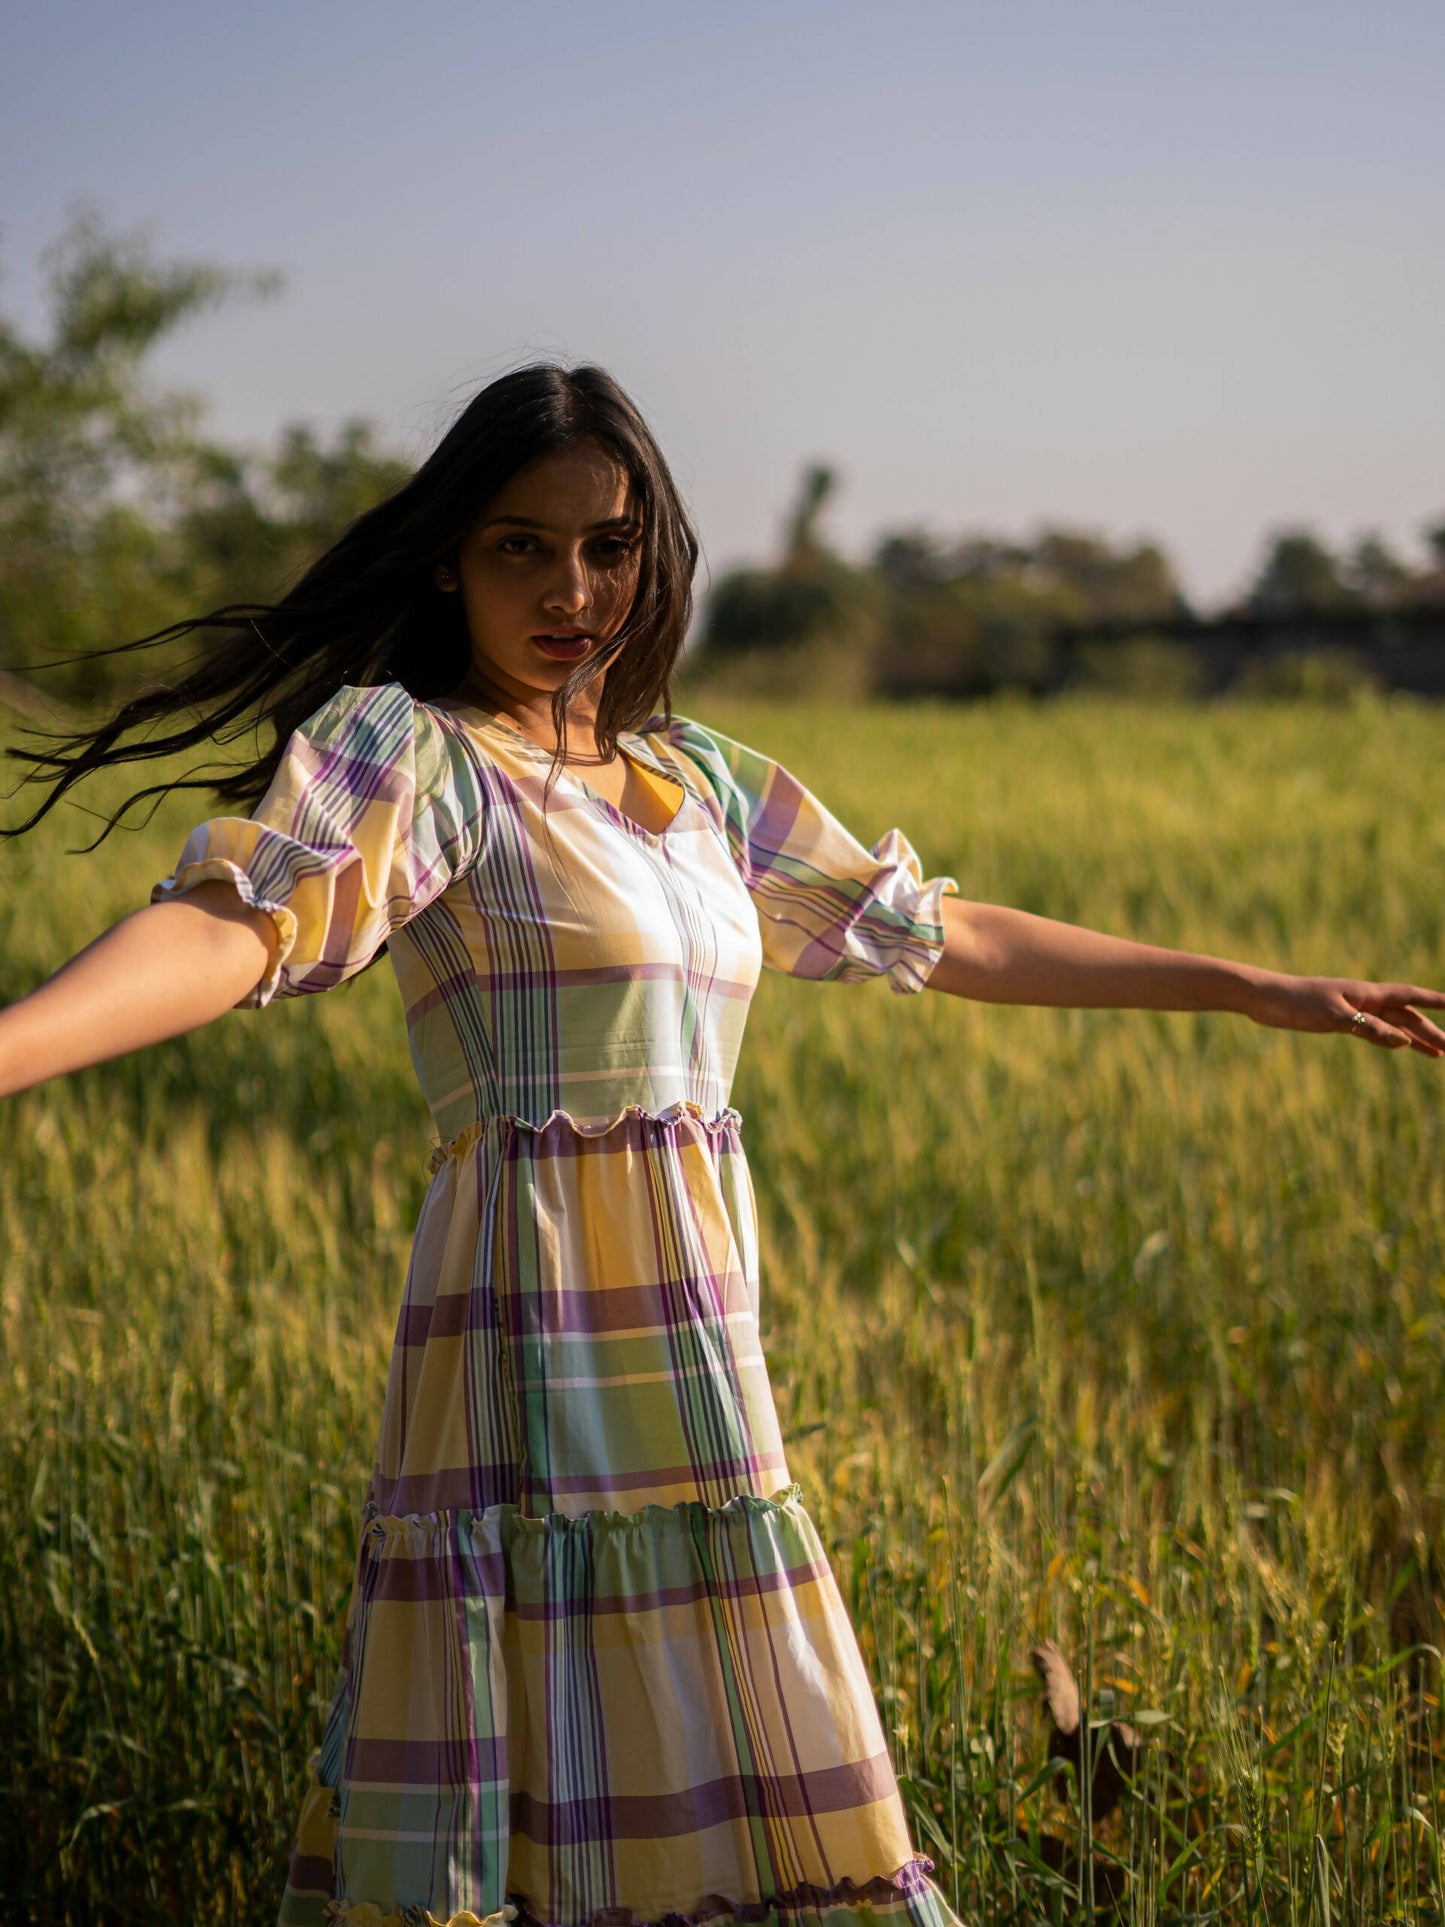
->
xmin=0 ymin=883 xmax=277 ymax=1096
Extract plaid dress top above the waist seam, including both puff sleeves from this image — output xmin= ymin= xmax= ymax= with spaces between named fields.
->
xmin=154 ymin=682 xmax=956 ymax=1141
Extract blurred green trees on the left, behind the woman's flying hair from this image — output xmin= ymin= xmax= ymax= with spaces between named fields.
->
xmin=0 ymin=214 xmax=410 ymax=701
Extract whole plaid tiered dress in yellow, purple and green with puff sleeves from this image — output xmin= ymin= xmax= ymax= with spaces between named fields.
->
xmin=152 ymin=684 xmax=956 ymax=1927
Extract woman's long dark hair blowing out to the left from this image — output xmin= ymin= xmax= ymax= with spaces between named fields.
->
xmin=0 ymin=362 xmax=697 ymax=850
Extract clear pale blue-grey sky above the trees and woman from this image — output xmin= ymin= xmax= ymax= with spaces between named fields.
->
xmin=0 ymin=0 xmax=1445 ymax=599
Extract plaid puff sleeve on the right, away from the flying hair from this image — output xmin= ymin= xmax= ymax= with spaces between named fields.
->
xmin=667 ymin=717 xmax=958 ymax=992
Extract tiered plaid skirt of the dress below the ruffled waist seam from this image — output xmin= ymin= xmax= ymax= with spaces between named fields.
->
xmin=281 ymin=1106 xmax=967 ymax=1927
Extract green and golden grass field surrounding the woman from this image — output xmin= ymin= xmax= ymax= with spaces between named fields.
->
xmin=0 ymin=703 xmax=1445 ymax=1927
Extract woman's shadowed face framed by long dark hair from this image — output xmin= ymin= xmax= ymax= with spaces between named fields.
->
xmin=437 ymin=441 xmax=642 ymax=703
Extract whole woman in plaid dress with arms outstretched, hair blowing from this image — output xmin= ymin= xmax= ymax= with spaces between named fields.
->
xmin=0 ymin=366 xmax=1445 ymax=1927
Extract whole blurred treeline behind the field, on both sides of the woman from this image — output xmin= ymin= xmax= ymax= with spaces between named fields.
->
xmin=0 ymin=216 xmax=1445 ymax=703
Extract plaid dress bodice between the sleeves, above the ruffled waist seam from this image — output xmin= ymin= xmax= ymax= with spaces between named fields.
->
xmin=389 ymin=717 xmax=763 ymax=1139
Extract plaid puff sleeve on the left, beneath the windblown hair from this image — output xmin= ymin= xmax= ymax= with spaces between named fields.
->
xmin=150 ymin=682 xmax=484 ymax=1008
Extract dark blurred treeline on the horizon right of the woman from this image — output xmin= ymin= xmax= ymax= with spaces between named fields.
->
xmin=697 ymin=468 xmax=1445 ymax=696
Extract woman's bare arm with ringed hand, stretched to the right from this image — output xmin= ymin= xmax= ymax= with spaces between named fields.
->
xmin=929 ymin=896 xmax=1445 ymax=1058
